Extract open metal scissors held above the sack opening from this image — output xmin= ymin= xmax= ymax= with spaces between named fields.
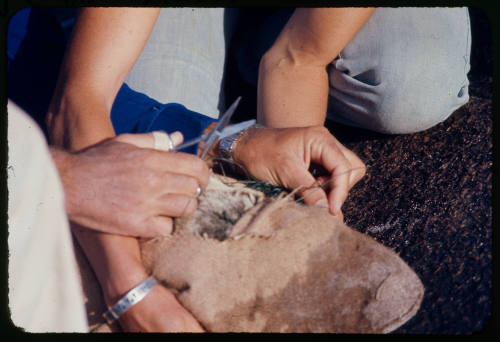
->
xmin=171 ymin=96 xmax=255 ymax=158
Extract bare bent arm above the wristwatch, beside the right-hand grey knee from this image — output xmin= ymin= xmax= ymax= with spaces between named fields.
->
xmin=257 ymin=8 xmax=375 ymax=127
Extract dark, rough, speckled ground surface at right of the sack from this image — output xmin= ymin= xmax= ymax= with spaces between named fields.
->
xmin=331 ymin=9 xmax=493 ymax=334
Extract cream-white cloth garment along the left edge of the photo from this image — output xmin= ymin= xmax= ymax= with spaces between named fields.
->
xmin=7 ymin=101 xmax=88 ymax=332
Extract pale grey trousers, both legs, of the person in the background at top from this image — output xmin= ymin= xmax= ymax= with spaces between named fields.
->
xmin=127 ymin=7 xmax=471 ymax=134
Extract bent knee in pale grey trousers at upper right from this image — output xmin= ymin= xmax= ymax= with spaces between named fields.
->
xmin=330 ymin=8 xmax=470 ymax=134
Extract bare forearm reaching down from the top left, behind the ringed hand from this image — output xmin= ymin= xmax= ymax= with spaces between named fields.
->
xmin=47 ymin=8 xmax=160 ymax=151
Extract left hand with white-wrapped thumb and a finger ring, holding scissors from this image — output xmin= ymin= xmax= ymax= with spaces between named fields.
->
xmin=56 ymin=133 xmax=209 ymax=237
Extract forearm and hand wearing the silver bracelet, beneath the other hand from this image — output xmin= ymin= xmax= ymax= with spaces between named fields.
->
xmin=72 ymin=222 xmax=203 ymax=332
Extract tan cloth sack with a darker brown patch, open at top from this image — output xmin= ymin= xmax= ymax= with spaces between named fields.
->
xmin=80 ymin=176 xmax=424 ymax=333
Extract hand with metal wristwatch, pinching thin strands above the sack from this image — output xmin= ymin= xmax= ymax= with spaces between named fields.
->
xmin=234 ymin=126 xmax=365 ymax=218
